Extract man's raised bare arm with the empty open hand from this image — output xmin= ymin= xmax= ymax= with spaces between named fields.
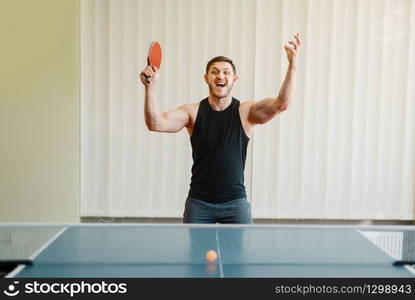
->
xmin=248 ymin=33 xmax=301 ymax=124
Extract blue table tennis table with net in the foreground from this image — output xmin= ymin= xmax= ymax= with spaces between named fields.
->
xmin=0 ymin=224 xmax=415 ymax=278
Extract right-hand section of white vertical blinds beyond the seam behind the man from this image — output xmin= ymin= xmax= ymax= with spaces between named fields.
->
xmin=252 ymin=0 xmax=415 ymax=219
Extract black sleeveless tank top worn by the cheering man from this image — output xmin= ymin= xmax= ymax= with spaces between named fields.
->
xmin=189 ymin=98 xmax=249 ymax=202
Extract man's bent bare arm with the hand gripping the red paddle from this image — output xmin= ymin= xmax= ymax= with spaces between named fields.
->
xmin=140 ymin=67 xmax=190 ymax=132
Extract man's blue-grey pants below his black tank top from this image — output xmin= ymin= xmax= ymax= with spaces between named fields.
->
xmin=183 ymin=197 xmax=252 ymax=224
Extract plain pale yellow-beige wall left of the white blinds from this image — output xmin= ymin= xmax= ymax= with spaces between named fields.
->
xmin=0 ymin=0 xmax=79 ymax=222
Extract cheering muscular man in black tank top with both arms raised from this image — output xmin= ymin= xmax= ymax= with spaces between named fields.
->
xmin=140 ymin=33 xmax=301 ymax=224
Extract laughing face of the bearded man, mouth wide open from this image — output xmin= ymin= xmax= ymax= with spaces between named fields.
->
xmin=205 ymin=61 xmax=238 ymax=98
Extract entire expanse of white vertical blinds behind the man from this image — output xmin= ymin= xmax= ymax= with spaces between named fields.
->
xmin=81 ymin=0 xmax=415 ymax=219
